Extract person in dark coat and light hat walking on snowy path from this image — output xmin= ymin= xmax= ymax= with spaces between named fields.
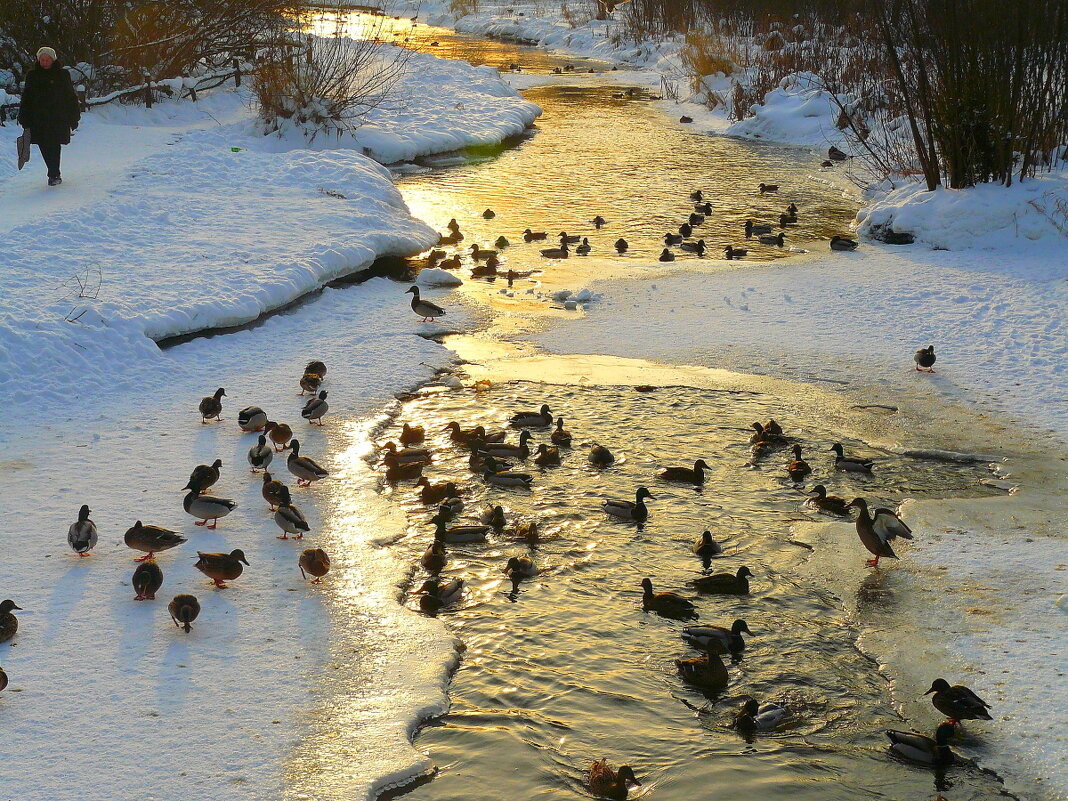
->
xmin=18 ymin=47 xmax=81 ymax=186
